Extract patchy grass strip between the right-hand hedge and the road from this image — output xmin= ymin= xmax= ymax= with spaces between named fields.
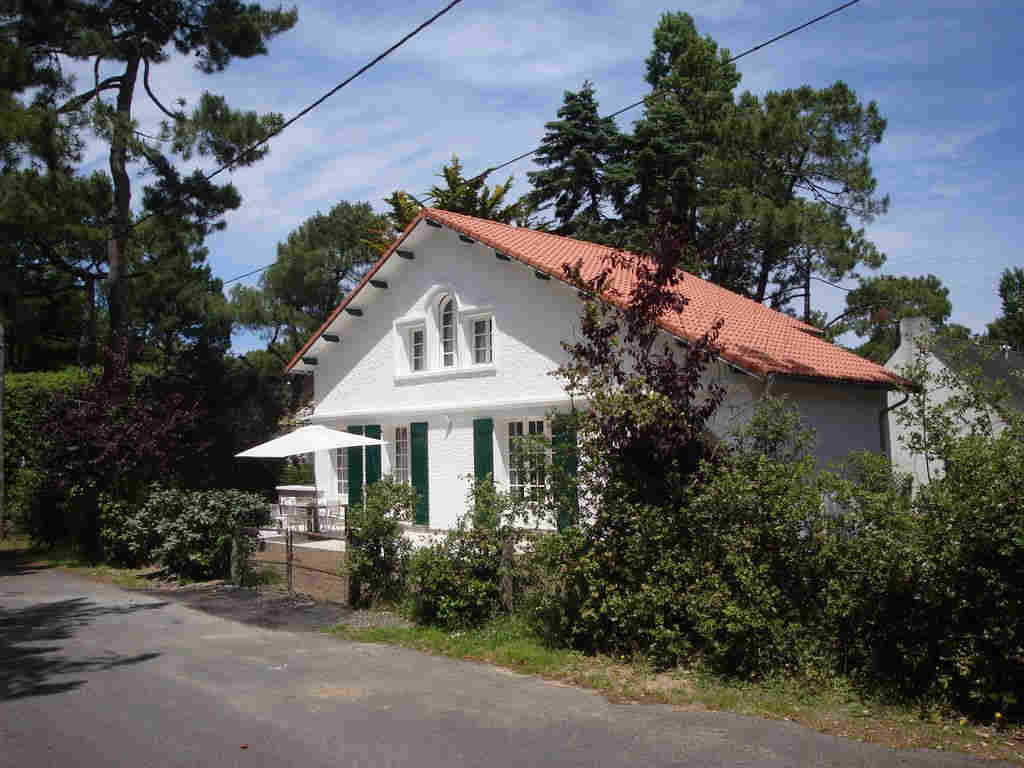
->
xmin=330 ymin=616 xmax=1024 ymax=765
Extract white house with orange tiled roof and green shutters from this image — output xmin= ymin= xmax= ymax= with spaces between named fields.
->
xmin=288 ymin=209 xmax=901 ymax=528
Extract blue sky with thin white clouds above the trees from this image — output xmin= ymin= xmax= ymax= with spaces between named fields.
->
xmin=74 ymin=0 xmax=1024 ymax=351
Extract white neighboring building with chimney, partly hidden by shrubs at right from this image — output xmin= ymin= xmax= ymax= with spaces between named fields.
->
xmin=886 ymin=317 xmax=1024 ymax=486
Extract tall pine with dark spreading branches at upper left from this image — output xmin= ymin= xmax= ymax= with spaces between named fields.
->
xmin=0 ymin=0 xmax=297 ymax=360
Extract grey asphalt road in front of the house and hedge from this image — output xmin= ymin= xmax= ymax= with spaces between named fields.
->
xmin=0 ymin=568 xmax=1007 ymax=768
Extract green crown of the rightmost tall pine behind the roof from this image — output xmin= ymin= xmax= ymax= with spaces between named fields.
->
xmin=696 ymin=82 xmax=889 ymax=309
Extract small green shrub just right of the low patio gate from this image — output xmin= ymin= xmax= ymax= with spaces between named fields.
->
xmin=345 ymin=477 xmax=417 ymax=605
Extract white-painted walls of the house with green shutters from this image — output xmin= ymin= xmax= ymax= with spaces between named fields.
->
xmin=308 ymin=226 xmax=884 ymax=528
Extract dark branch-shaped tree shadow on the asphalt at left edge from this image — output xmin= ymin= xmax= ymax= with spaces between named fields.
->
xmin=0 ymin=597 xmax=167 ymax=700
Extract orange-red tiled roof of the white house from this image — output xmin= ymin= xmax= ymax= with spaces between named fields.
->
xmin=287 ymin=208 xmax=905 ymax=388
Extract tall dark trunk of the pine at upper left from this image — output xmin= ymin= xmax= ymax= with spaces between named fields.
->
xmin=106 ymin=54 xmax=139 ymax=362
